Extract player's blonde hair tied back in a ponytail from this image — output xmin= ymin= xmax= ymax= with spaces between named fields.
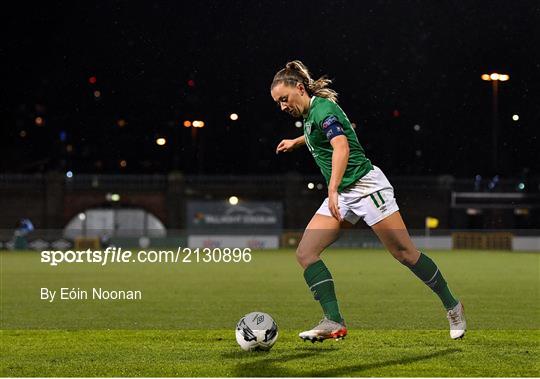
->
xmin=270 ymin=60 xmax=338 ymax=102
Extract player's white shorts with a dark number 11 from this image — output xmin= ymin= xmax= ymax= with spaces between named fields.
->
xmin=316 ymin=166 xmax=399 ymax=226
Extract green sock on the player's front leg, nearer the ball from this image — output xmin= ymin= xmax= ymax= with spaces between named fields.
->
xmin=304 ymin=260 xmax=343 ymax=322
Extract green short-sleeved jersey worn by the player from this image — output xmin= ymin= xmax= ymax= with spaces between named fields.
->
xmin=304 ymin=96 xmax=373 ymax=192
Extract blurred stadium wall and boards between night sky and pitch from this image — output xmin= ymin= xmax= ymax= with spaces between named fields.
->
xmin=0 ymin=172 xmax=540 ymax=251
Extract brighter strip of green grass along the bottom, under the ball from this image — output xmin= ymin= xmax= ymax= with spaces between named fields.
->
xmin=2 ymin=329 xmax=540 ymax=377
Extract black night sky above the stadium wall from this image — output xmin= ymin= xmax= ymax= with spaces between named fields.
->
xmin=4 ymin=0 xmax=540 ymax=177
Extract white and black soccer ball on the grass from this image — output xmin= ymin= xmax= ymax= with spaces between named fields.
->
xmin=236 ymin=312 xmax=278 ymax=351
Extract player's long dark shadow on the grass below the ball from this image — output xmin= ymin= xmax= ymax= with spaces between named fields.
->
xmin=231 ymin=348 xmax=461 ymax=377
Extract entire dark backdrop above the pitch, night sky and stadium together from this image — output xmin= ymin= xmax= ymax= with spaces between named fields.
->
xmin=0 ymin=0 xmax=540 ymax=250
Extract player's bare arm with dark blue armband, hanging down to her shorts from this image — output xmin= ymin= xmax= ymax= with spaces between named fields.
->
xmin=321 ymin=116 xmax=349 ymax=221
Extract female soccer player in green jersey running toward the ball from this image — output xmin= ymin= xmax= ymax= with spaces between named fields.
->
xmin=270 ymin=60 xmax=466 ymax=342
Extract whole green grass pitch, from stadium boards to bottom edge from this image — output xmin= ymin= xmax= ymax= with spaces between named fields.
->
xmin=0 ymin=249 xmax=540 ymax=377
